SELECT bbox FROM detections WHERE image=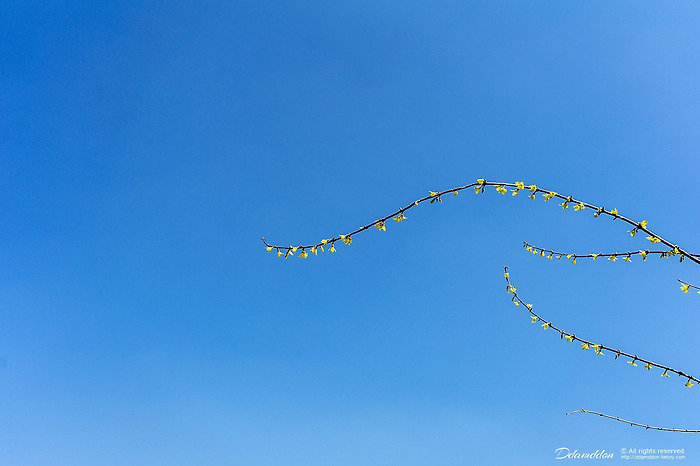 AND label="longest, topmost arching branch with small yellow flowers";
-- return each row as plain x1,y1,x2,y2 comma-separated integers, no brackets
262,179,700,264
